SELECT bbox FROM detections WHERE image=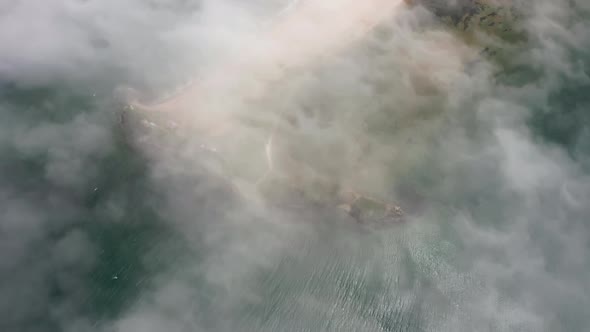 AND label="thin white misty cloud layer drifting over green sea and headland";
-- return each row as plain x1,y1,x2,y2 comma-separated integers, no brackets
0,0,590,331
